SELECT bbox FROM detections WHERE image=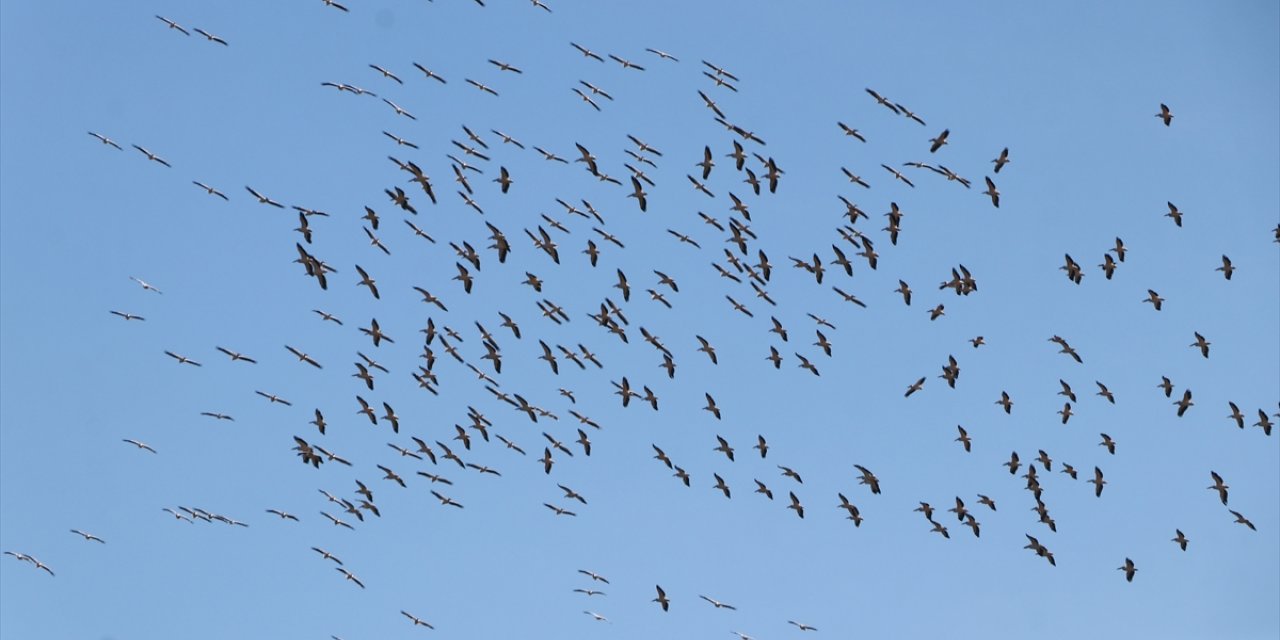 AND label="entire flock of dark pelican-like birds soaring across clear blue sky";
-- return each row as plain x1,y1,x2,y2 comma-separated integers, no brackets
4,0,1280,640
